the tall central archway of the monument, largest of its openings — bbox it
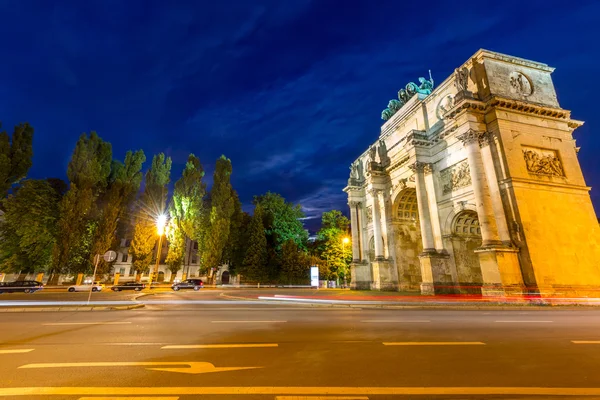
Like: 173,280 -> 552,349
392,188 -> 423,290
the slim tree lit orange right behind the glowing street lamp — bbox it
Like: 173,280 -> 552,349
129,153 -> 172,279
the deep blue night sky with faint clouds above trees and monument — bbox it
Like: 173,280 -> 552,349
0,0 -> 600,229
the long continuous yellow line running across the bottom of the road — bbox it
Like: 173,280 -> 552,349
0,386 -> 600,396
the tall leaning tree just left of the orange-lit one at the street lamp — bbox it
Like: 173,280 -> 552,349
92,150 -> 146,274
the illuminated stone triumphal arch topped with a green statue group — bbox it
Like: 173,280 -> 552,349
344,50 -> 600,296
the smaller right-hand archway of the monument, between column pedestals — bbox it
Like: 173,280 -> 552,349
451,210 -> 483,293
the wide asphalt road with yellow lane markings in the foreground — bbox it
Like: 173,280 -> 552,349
0,304 -> 600,400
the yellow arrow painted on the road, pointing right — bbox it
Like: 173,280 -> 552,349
19,361 -> 262,374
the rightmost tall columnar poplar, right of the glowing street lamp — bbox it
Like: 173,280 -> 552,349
202,156 -> 234,278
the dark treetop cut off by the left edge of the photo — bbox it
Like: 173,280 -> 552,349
0,123 -> 33,199
